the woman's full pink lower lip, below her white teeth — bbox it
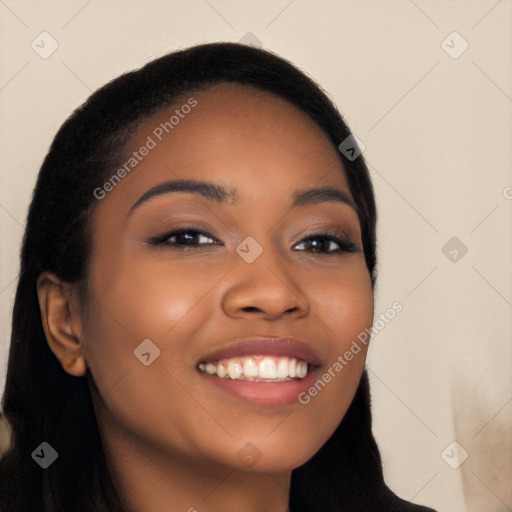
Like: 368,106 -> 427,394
197,368 -> 318,407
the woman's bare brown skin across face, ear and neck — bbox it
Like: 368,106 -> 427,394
38,84 -> 373,512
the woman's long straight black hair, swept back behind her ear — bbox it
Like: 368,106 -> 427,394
0,43 -> 434,512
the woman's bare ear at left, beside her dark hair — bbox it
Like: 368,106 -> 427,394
36,272 -> 87,377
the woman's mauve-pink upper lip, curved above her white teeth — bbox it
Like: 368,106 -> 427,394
199,336 -> 322,366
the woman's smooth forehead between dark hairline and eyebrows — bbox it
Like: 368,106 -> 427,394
98,83 -> 350,211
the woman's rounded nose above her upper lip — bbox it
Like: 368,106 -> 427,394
222,250 -> 310,320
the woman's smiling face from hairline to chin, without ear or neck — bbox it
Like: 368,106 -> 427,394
82,84 -> 373,472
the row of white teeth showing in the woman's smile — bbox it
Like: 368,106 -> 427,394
197,355 -> 311,382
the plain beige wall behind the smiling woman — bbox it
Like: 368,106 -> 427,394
0,0 -> 512,512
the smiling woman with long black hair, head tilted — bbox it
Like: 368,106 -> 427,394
0,43 -> 431,512
